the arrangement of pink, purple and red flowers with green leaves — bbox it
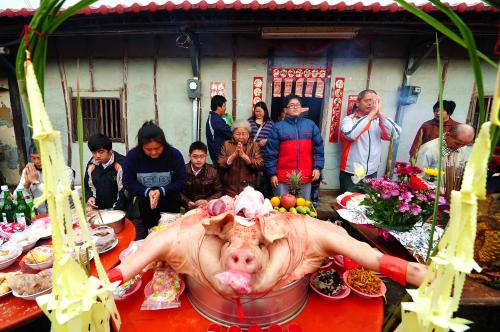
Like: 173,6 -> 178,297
359,162 -> 446,232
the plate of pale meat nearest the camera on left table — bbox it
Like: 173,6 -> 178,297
7,269 -> 52,300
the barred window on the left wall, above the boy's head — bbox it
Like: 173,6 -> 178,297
71,97 -> 125,142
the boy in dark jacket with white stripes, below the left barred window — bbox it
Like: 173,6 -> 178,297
84,134 -> 127,210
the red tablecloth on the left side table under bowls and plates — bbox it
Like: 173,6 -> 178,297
0,220 -> 135,331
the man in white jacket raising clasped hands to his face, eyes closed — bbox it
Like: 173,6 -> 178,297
339,89 -> 401,193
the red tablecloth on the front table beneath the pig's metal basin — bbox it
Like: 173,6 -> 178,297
116,273 -> 384,332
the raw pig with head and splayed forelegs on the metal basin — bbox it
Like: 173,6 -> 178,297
118,192 -> 426,297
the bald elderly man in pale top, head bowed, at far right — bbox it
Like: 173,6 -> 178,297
416,124 -> 474,168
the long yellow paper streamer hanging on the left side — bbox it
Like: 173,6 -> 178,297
25,54 -> 120,332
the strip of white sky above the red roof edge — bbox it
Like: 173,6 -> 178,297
0,0 -> 488,9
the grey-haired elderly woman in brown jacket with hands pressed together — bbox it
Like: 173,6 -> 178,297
218,120 -> 264,196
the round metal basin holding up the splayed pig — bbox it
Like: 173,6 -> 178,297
186,276 -> 309,329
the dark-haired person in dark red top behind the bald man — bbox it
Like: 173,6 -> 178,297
410,100 -> 460,160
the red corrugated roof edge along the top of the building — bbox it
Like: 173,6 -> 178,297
0,0 -> 497,17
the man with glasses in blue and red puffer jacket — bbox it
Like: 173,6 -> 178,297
264,95 -> 325,199
